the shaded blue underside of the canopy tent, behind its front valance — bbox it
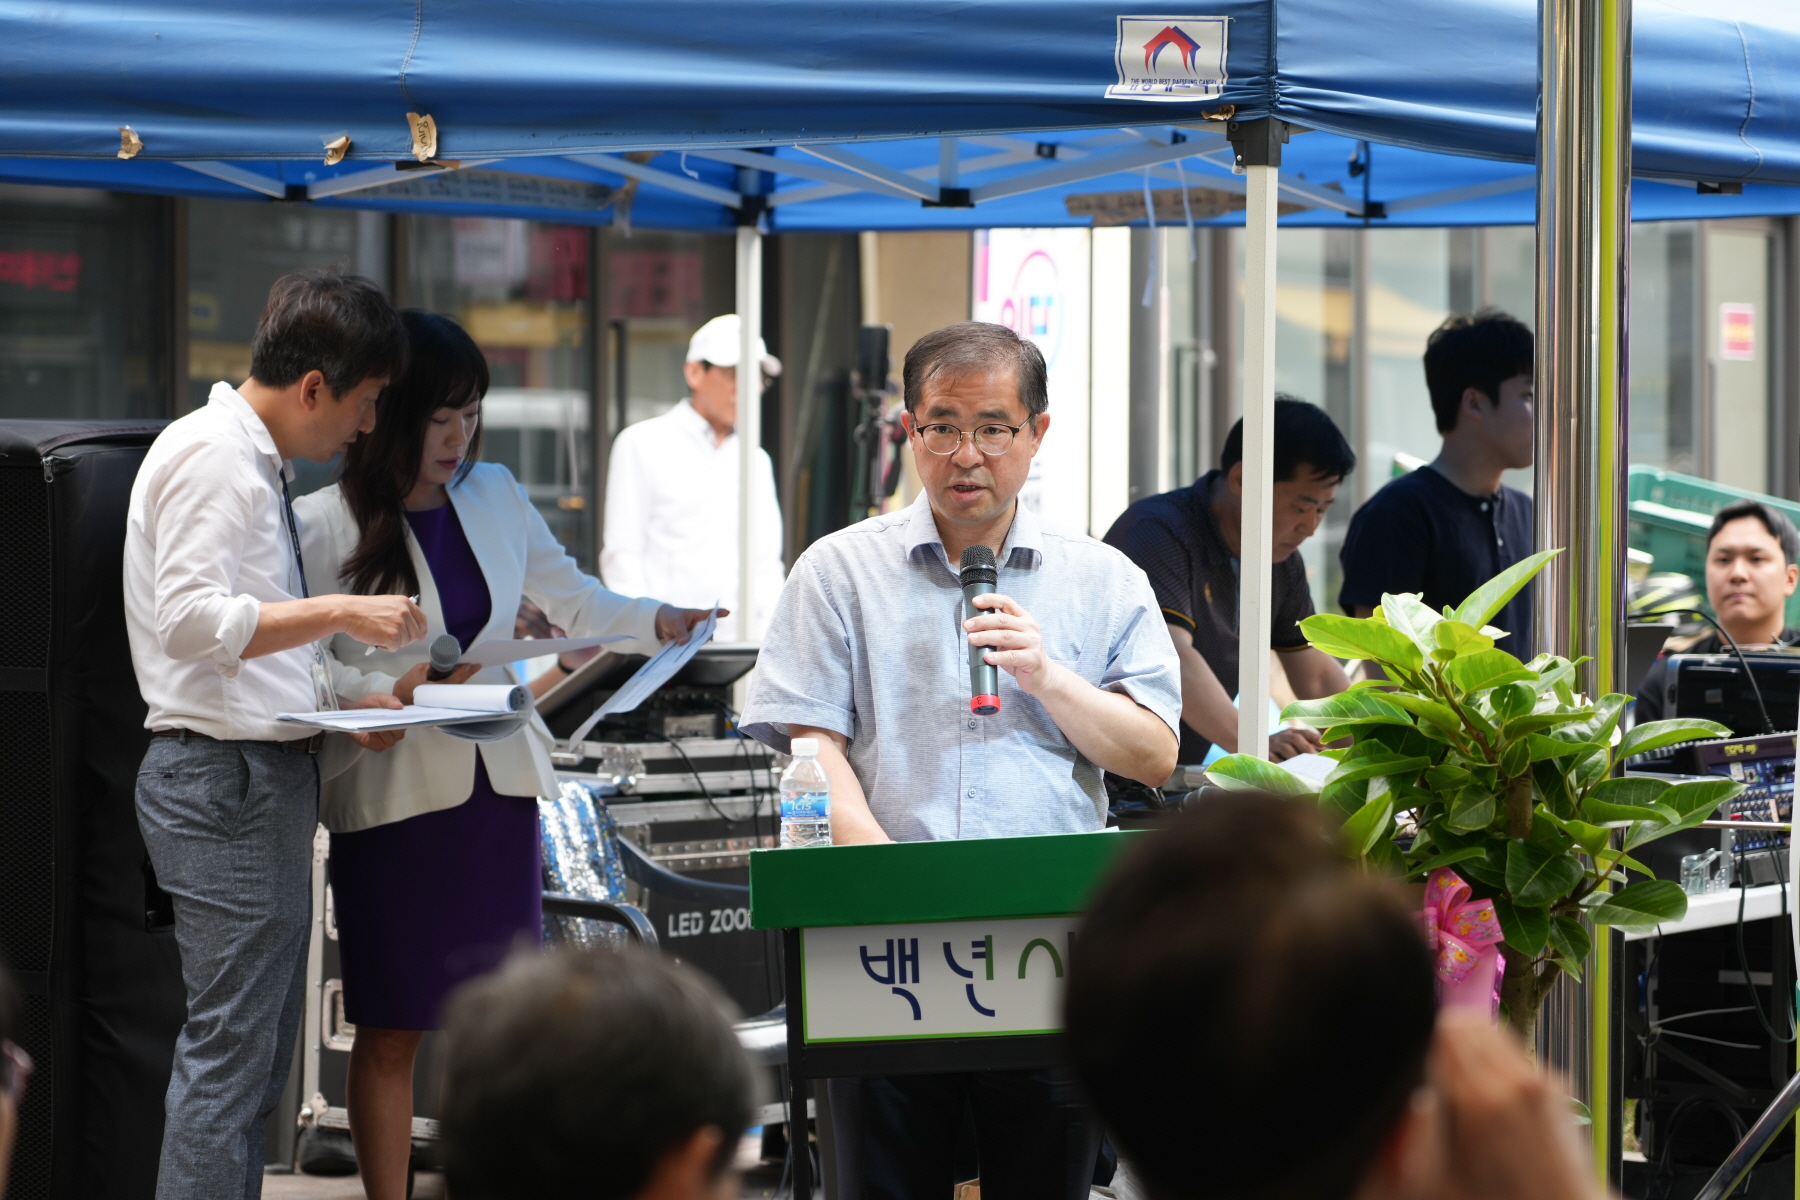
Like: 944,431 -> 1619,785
0,126 -> 1800,234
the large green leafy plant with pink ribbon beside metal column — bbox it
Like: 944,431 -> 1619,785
1208,551 -> 1742,1045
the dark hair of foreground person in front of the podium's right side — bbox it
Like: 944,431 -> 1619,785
1066,792 -> 1436,1200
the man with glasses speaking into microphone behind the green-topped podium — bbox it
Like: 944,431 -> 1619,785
743,322 -> 1181,1200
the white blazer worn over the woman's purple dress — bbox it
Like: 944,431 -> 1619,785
293,462 -> 661,833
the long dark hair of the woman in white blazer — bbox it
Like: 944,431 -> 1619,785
338,308 -> 488,596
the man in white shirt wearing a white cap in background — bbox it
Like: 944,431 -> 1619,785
599,313 -> 785,642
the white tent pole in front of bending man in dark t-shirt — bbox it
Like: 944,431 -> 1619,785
1228,117 -> 1289,759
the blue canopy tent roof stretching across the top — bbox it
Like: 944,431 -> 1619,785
0,0 -> 1800,232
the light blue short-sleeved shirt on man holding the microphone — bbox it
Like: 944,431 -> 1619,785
743,497 -> 1181,842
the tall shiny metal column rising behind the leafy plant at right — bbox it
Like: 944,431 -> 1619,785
1535,0 -> 1631,1178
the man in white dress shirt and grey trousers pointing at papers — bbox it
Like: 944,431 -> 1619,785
124,272 -> 425,1200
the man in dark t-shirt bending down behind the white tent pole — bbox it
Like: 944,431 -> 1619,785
1105,396 -> 1355,765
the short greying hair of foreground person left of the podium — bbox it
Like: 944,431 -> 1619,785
441,950 -> 752,1200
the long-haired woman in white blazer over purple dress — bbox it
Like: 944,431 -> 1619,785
295,311 -> 706,1200
